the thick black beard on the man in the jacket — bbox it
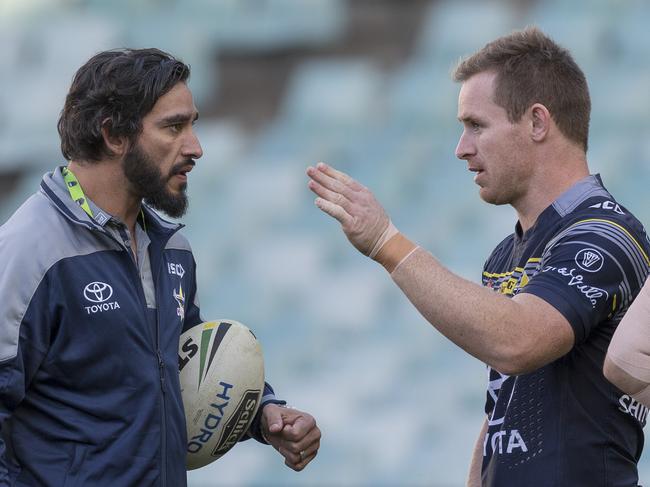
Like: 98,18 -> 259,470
122,144 -> 194,218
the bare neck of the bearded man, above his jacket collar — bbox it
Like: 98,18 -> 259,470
68,160 -> 142,235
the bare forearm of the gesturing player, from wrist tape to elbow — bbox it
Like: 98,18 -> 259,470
382,249 -> 570,375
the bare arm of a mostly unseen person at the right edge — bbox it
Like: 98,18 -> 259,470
604,280 -> 650,407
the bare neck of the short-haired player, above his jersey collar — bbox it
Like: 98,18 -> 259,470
512,148 -> 589,232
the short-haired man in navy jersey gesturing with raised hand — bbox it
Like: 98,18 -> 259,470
307,28 -> 650,487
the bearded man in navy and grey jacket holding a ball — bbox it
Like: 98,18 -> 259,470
0,49 -> 320,487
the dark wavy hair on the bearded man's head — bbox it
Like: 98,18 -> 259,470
57,49 -> 190,162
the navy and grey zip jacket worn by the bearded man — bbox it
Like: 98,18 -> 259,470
0,169 -> 274,487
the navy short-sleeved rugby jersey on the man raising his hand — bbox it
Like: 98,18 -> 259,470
482,176 -> 650,487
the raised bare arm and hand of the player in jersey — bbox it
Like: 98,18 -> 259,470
307,163 -> 574,375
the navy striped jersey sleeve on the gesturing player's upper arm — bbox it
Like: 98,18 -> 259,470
521,219 -> 650,343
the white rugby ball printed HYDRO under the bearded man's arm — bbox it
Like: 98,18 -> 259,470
178,320 -> 264,470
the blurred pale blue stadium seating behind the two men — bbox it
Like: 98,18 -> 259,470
0,0 -> 650,487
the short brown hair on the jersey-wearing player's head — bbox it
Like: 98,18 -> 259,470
453,27 -> 591,152
